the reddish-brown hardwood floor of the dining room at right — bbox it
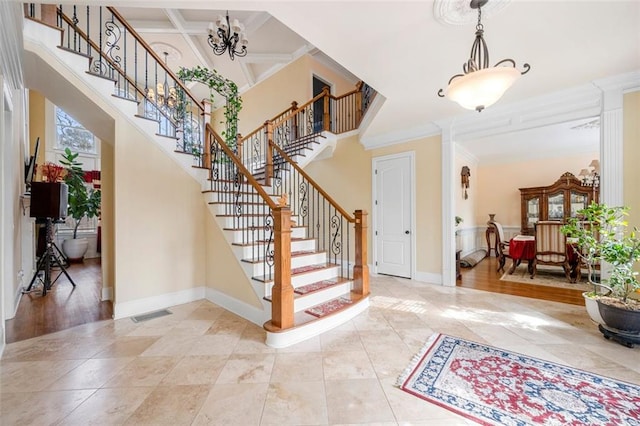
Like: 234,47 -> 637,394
457,253 -> 584,305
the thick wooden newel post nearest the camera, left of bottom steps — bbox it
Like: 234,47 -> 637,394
271,206 -> 294,330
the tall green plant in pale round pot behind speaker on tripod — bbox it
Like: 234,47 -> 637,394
60,148 -> 101,262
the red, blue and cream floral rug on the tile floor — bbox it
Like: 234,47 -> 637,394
398,334 -> 640,426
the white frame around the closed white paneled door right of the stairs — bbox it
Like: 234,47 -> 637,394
369,151 -> 416,279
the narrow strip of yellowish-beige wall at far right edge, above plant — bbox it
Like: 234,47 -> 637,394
622,91 -> 640,227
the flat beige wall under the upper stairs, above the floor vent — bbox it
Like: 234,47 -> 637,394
114,119 -> 206,303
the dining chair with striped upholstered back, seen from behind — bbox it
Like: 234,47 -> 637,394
531,220 -> 571,281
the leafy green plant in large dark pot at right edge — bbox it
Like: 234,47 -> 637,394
562,202 -> 640,339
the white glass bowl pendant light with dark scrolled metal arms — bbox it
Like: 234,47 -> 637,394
438,0 -> 531,112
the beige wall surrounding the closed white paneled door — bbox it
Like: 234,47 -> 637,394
305,136 -> 442,274
